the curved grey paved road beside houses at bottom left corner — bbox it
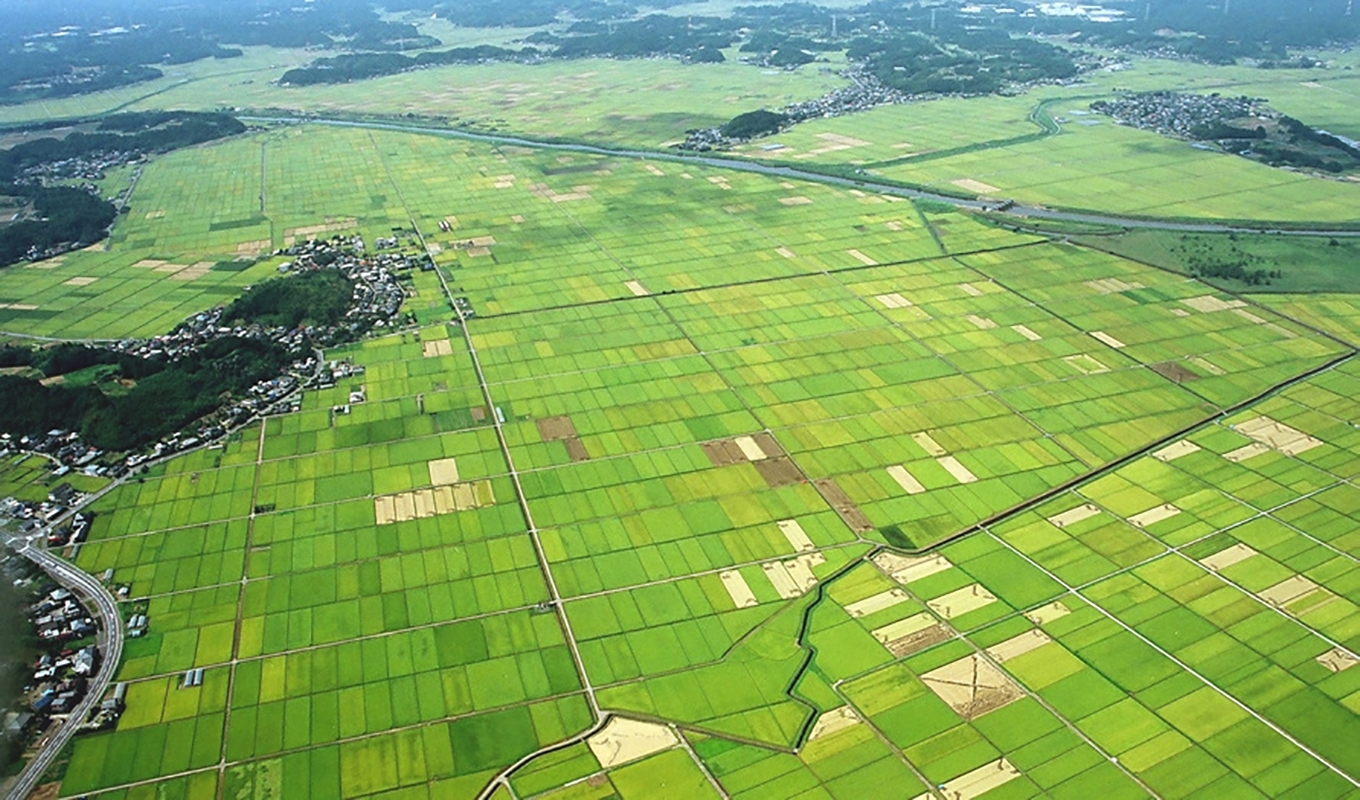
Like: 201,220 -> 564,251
8,529 -> 124,800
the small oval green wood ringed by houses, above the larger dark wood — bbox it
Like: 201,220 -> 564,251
222,269 -> 354,328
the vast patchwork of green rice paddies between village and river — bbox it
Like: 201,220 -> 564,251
10,125 -> 1360,800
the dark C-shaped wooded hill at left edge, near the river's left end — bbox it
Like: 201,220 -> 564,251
0,112 -> 246,267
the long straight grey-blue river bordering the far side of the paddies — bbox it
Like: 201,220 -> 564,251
241,116 -> 1360,238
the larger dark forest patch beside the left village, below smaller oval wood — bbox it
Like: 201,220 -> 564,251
0,337 -> 291,450
